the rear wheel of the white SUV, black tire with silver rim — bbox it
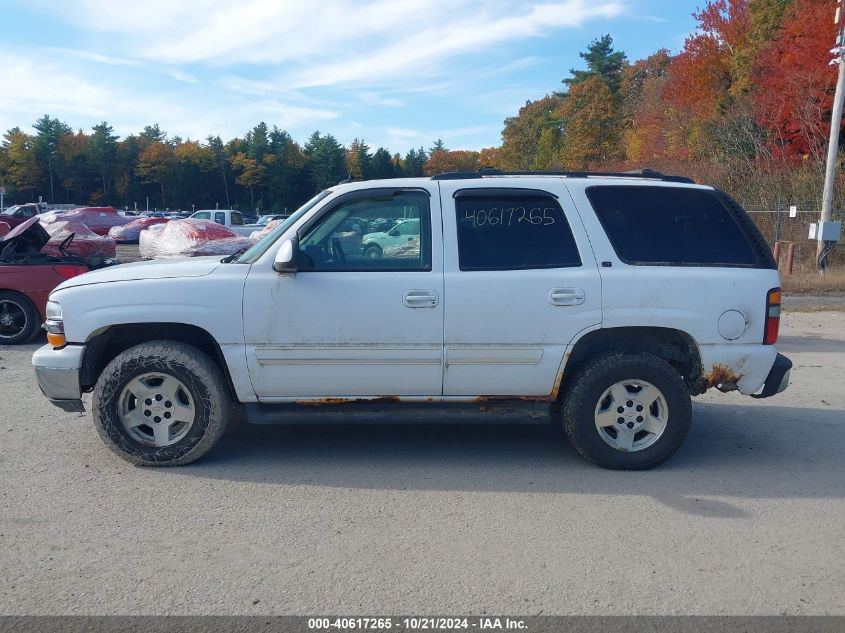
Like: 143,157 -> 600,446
562,353 -> 692,470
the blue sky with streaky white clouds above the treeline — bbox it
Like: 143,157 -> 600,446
0,0 -> 702,154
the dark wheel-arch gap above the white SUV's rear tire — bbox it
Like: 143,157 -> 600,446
560,327 -> 706,395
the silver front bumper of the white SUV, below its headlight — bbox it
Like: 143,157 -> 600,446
32,345 -> 85,413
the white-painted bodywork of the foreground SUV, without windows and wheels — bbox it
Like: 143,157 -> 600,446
33,177 -> 779,402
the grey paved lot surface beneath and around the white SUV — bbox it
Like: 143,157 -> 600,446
0,313 -> 845,614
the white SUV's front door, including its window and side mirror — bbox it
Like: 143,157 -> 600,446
244,187 -> 443,402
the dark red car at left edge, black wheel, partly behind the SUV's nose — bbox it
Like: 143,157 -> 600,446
0,217 -> 88,345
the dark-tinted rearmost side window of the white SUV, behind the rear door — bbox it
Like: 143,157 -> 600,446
586,185 -> 768,267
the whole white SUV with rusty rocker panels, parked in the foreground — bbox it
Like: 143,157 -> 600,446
33,170 -> 791,469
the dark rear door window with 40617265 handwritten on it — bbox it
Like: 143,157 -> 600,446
455,189 -> 581,271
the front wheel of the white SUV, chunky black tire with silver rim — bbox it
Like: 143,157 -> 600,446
92,341 -> 232,466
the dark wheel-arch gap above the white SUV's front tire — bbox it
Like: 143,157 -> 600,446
80,322 -> 238,402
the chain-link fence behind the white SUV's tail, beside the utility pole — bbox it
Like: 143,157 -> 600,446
743,201 -> 845,273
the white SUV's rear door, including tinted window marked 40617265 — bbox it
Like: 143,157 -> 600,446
440,179 -> 601,396
